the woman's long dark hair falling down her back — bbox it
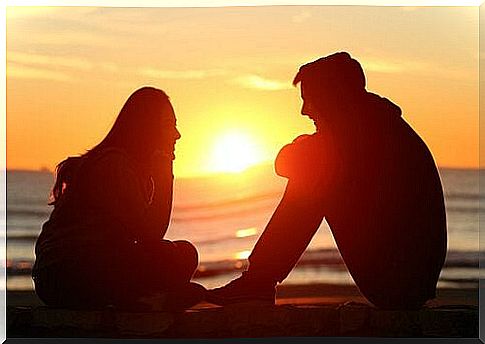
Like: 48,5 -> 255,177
49,87 -> 169,205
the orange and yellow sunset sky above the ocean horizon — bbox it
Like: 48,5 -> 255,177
7,6 -> 478,176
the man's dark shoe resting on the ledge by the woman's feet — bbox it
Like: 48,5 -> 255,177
206,272 -> 276,306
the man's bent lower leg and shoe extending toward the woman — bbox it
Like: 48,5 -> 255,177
208,183 -> 323,304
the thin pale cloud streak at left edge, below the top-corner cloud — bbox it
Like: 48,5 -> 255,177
7,52 -> 93,71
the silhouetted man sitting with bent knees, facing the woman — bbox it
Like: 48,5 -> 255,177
208,52 -> 447,309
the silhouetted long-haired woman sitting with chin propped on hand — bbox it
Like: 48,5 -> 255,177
33,87 -> 204,309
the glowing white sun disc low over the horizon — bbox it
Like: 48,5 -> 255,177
211,132 -> 261,173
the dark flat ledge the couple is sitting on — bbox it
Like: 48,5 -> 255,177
7,303 -> 478,338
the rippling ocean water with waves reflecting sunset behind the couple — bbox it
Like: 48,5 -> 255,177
6,165 -> 485,290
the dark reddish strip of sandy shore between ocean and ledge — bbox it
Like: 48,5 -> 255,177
7,284 -> 478,309
